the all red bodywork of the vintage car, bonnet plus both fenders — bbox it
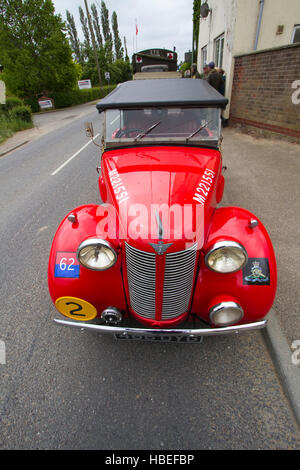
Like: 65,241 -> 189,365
48,146 -> 276,327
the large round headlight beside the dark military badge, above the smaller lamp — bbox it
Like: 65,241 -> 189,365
205,241 -> 248,273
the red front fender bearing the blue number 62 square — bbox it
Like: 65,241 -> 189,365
48,205 -> 127,320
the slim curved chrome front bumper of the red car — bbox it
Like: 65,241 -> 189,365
54,319 -> 267,339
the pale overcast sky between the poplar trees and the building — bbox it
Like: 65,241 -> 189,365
52,0 -> 193,64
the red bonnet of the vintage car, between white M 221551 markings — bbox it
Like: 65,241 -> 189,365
102,147 -> 223,253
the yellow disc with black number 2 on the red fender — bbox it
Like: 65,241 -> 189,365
55,297 -> 97,321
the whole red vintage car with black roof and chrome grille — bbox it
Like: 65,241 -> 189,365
48,79 -> 277,342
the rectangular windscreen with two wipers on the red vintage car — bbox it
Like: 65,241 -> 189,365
106,108 -> 221,144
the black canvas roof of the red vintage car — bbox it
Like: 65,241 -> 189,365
97,78 -> 228,113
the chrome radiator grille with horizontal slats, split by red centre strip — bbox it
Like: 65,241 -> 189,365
126,243 -> 196,320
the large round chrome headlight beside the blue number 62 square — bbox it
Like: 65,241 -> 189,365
77,238 -> 117,271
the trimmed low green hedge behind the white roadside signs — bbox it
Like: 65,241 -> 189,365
24,85 -> 116,112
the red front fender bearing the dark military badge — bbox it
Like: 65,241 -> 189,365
192,207 -> 277,323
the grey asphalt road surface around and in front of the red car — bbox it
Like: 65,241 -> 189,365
0,105 -> 300,450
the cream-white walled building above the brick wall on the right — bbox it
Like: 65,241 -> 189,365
197,0 -> 300,118
